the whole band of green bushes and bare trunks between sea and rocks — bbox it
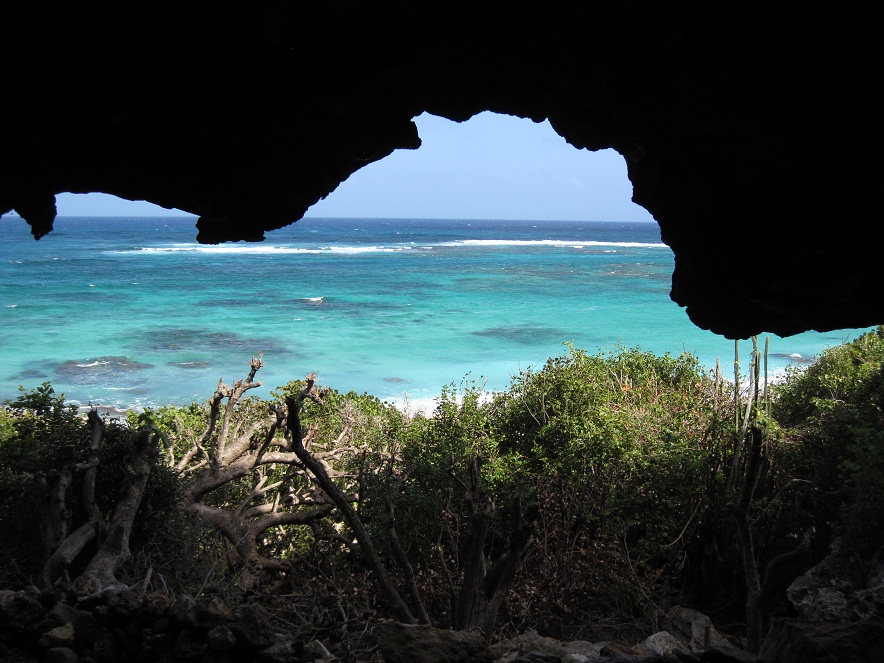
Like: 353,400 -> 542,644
0,328 -> 884,648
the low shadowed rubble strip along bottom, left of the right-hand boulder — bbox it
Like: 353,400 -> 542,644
0,589 -> 753,663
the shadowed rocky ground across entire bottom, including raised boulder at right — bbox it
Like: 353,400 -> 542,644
0,541 -> 884,663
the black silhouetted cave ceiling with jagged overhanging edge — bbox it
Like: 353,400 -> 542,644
0,0 -> 884,337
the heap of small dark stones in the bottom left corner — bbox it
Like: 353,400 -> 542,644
0,590 -> 308,663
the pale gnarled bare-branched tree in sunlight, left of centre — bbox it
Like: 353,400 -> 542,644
143,357 -> 346,589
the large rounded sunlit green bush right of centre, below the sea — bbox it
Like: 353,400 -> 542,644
490,348 -> 718,553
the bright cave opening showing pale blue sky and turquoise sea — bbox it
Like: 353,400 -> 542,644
3,113 -> 872,407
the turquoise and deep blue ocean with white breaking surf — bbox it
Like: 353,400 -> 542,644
0,216 -> 861,416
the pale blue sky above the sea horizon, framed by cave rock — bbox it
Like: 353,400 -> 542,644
50,112 -> 653,221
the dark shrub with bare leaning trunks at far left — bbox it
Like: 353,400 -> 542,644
0,383 -> 165,595
